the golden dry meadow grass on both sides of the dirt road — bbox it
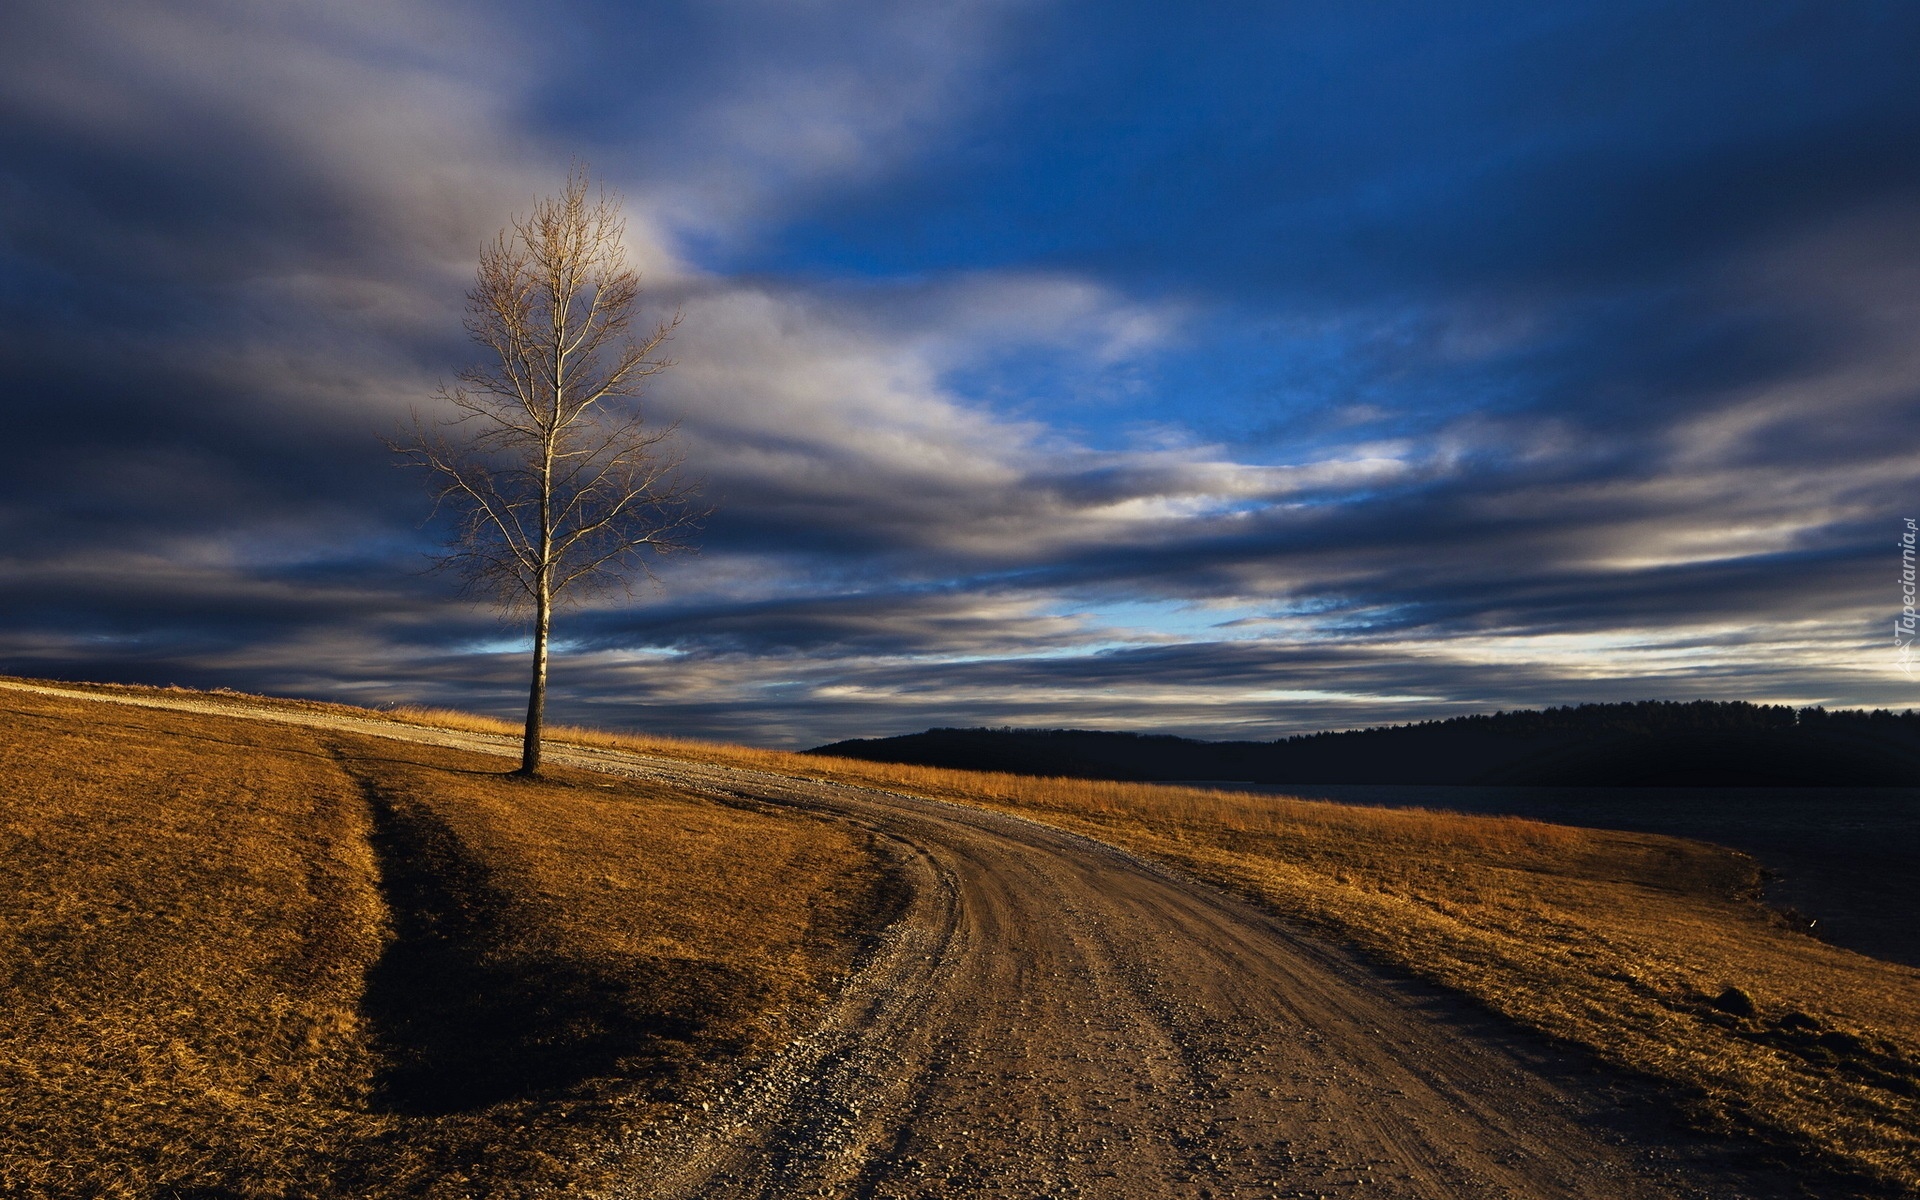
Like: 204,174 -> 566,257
11,679 -> 1920,1196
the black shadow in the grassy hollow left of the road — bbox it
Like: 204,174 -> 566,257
361,764 -> 743,1116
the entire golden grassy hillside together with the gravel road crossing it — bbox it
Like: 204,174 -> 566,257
11,682 -> 1920,1200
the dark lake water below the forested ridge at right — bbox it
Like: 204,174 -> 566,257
1204,781 -> 1920,966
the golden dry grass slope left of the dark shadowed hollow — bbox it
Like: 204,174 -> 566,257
0,695 -> 382,1196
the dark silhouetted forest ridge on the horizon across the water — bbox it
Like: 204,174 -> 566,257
808,701 -> 1920,787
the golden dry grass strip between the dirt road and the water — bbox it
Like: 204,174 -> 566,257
370,710 -> 1920,1194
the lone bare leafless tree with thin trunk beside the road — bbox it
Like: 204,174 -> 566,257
394,171 -> 703,776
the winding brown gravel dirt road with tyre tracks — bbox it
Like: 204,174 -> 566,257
0,693 -> 1788,1200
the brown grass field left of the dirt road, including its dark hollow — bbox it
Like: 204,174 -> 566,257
0,691 -> 876,1200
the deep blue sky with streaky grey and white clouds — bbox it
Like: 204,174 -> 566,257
0,0 -> 1920,747
